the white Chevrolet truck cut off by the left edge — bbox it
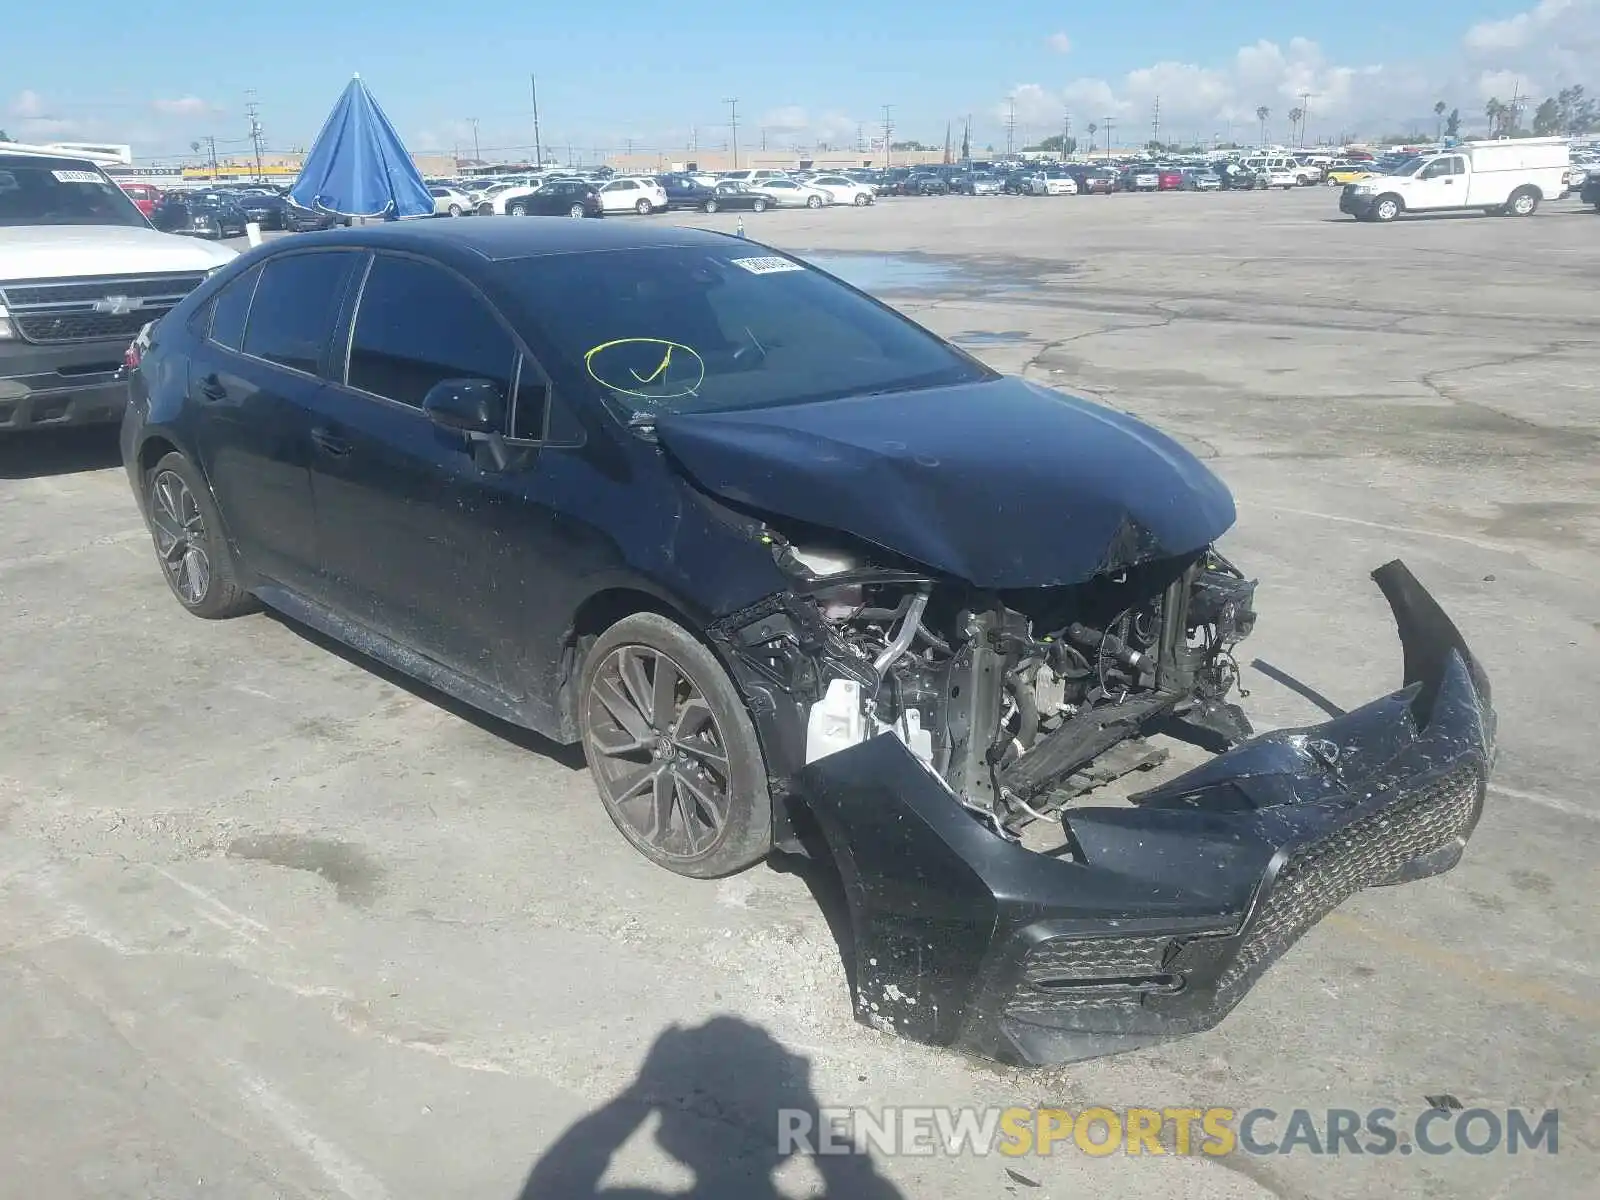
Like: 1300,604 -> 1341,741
0,142 -> 235,437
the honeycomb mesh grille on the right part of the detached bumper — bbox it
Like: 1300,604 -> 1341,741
1218,765 -> 1483,1005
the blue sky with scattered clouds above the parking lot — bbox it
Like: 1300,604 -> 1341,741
0,0 -> 1600,157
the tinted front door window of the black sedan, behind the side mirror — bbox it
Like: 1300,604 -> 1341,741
349,258 -> 518,412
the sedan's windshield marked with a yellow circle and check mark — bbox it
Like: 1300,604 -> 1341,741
504,246 -> 992,419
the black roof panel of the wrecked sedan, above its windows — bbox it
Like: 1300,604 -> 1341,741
270,216 -> 742,262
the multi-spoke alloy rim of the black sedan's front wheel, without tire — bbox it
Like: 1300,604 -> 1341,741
584,645 -> 730,859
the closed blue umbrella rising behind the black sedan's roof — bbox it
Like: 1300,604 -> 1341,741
290,75 -> 434,218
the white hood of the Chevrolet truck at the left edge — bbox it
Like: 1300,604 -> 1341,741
0,226 -> 235,280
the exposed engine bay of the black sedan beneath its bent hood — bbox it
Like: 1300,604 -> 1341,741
713,531 -> 1256,840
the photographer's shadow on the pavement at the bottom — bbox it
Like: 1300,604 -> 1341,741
520,1016 -> 904,1200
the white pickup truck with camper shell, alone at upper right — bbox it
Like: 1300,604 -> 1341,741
1339,138 -> 1571,221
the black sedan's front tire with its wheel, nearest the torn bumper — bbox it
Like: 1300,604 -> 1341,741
578,613 -> 773,878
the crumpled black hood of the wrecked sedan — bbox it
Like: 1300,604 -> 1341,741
656,378 -> 1235,589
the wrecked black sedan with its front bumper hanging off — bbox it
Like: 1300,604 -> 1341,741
122,221 -> 1494,1064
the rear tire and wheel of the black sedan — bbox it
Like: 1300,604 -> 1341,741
144,451 -> 256,621
